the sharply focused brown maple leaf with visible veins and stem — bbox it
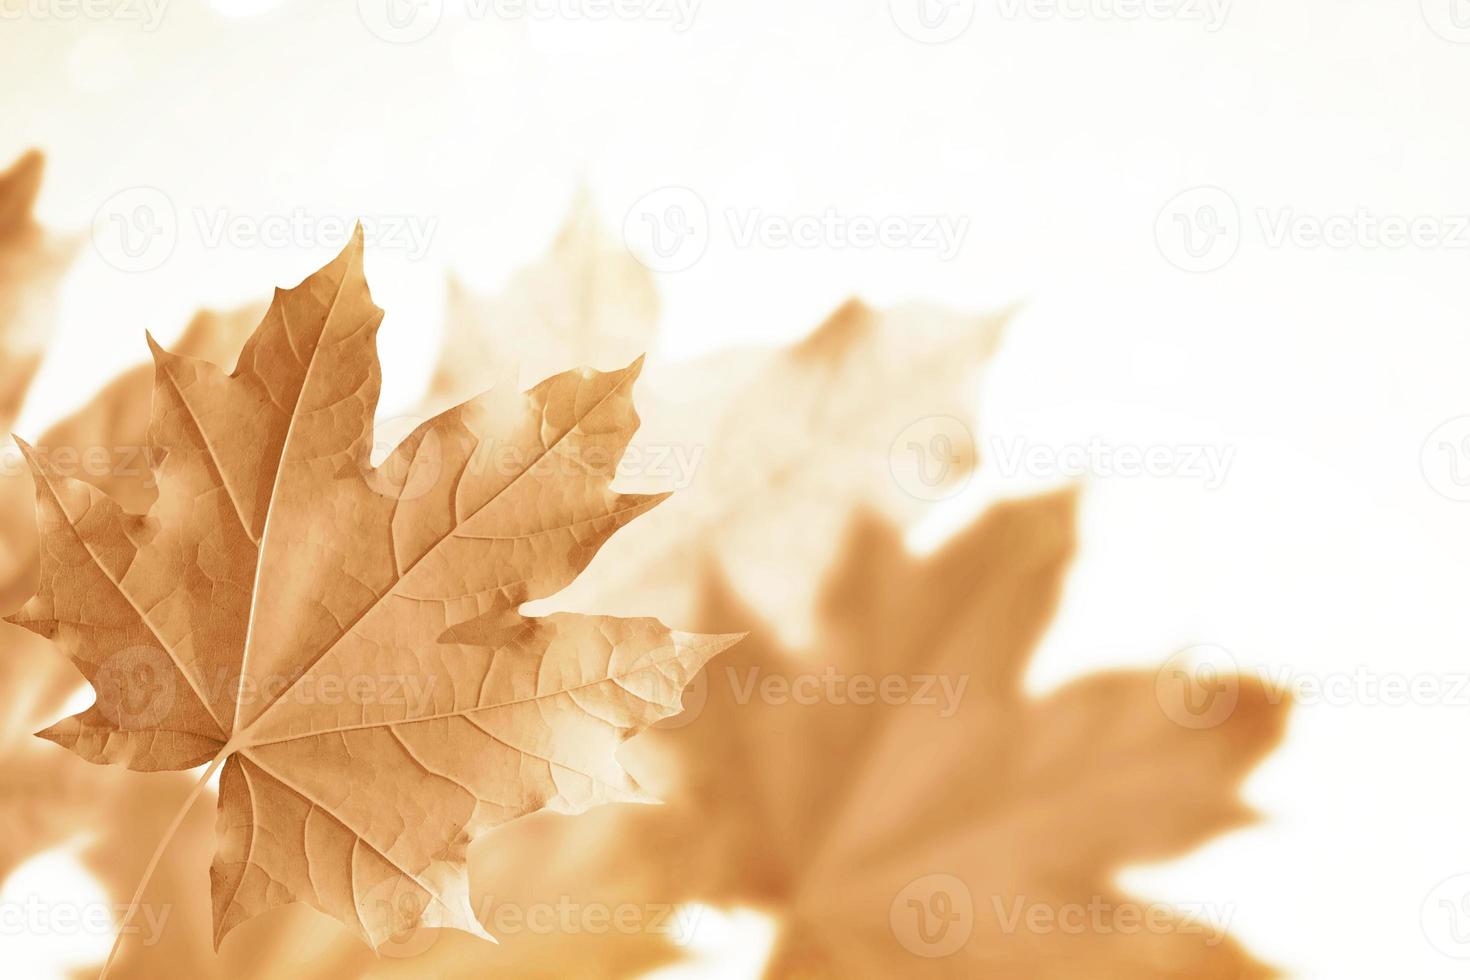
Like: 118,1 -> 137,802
12,234 -> 735,946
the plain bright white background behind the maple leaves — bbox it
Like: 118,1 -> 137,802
0,0 -> 1470,980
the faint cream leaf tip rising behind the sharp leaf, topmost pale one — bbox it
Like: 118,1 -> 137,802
431,192 -> 659,404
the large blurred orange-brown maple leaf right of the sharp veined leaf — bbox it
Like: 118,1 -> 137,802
467,494 -> 1285,980
